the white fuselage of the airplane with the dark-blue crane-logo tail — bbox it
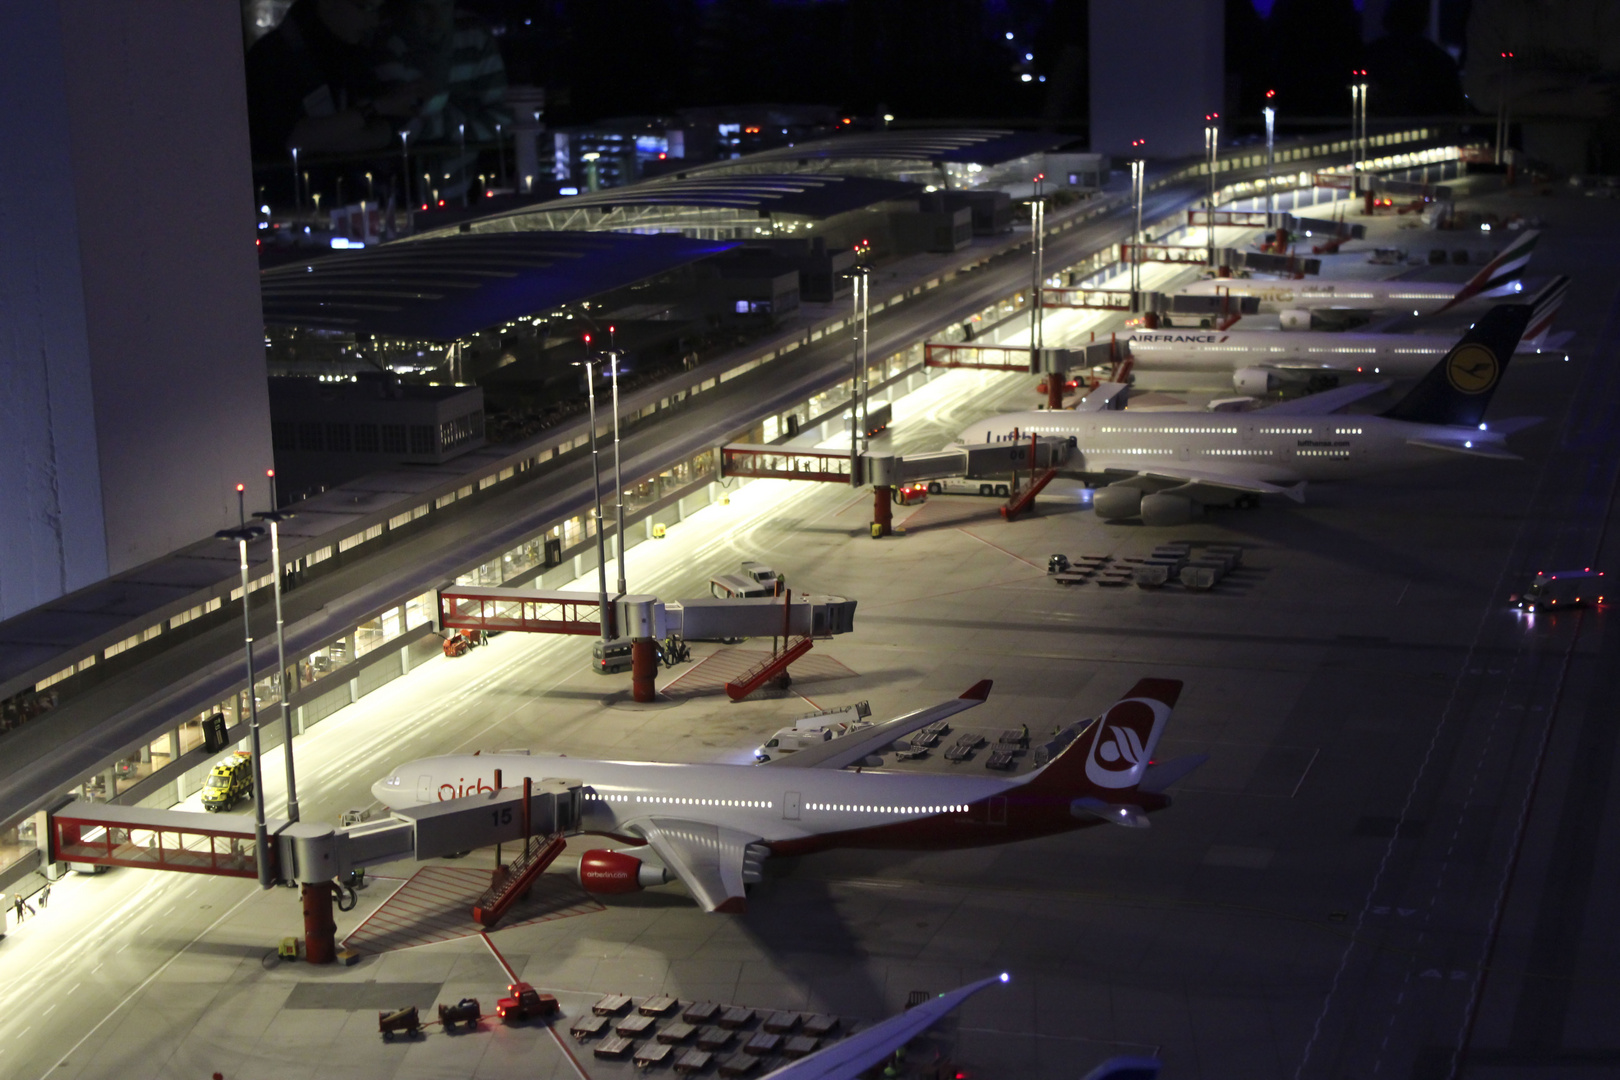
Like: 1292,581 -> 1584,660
957,410 -> 1503,484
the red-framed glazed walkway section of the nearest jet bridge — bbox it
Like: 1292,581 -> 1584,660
49,801 -> 275,879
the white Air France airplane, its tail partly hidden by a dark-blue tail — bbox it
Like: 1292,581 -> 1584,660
1121,277 -> 1570,393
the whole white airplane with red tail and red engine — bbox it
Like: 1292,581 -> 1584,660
371,678 -> 1207,913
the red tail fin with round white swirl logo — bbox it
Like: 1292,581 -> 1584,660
1022,678 -> 1181,826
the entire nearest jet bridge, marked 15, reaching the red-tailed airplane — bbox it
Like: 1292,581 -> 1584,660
45,772 -> 585,963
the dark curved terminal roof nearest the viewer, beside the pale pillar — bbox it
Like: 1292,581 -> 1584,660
259,232 -> 735,342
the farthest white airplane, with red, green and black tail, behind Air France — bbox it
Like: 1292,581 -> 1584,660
1178,230 -> 1541,318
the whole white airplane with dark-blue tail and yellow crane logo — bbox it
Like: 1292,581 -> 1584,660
956,304 -> 1539,525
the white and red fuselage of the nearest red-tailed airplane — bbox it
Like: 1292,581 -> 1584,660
371,755 -> 1166,855
